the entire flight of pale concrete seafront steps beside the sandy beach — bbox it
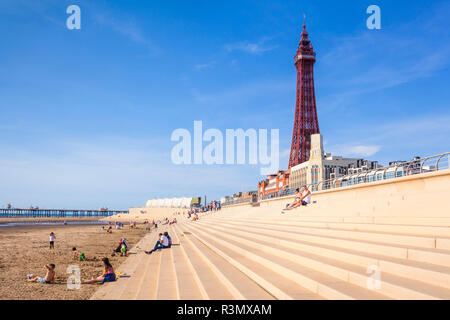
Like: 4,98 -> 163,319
91,170 -> 450,300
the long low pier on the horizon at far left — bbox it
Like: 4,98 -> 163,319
0,209 -> 128,218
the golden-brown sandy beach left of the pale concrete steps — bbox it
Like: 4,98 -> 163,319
0,225 -> 146,300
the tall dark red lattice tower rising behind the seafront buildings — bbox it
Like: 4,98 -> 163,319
289,24 -> 320,168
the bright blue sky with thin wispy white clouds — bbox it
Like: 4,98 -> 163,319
0,0 -> 450,209
